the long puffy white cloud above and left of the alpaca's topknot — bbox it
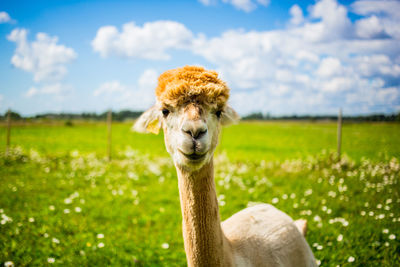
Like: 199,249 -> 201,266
92,21 -> 193,60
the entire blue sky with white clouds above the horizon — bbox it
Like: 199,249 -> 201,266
0,0 -> 400,115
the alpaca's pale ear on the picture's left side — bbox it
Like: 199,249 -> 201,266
132,106 -> 161,134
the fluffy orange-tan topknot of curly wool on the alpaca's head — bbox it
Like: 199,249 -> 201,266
156,66 -> 229,107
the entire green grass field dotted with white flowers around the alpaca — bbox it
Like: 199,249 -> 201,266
0,122 -> 400,266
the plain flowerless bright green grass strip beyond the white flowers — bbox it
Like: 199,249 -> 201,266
0,122 -> 400,161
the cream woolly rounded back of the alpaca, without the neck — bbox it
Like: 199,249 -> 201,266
221,204 -> 316,267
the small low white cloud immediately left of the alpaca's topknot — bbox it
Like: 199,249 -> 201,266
93,69 -> 158,110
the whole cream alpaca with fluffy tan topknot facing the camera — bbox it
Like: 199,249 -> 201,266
133,66 -> 315,266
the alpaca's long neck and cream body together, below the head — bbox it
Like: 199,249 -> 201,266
177,159 -> 315,267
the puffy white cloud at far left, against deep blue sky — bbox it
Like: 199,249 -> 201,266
7,29 -> 77,82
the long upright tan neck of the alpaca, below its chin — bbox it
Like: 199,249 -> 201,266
177,159 -> 232,267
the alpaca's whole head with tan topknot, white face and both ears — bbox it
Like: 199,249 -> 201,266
134,66 -> 239,171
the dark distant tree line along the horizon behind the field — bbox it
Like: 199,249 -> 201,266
0,110 -> 400,122
